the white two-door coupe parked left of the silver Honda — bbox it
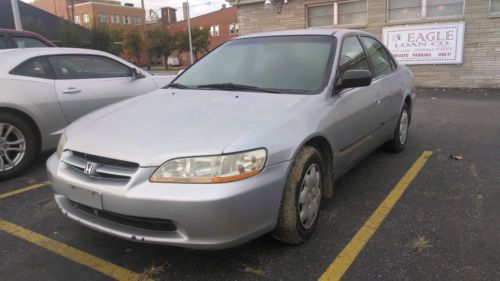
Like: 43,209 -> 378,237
0,48 -> 175,179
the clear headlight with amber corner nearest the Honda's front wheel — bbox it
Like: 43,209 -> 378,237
150,149 -> 267,183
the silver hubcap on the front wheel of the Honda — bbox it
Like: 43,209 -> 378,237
298,164 -> 321,229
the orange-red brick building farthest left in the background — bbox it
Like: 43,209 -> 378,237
32,0 -> 145,30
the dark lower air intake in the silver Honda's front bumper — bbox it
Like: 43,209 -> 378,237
71,201 -> 177,231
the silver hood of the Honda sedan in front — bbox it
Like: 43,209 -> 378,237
65,89 -> 307,167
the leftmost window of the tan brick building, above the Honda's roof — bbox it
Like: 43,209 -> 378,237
307,0 -> 368,27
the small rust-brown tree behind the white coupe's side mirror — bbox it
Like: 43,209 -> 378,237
146,27 -> 176,69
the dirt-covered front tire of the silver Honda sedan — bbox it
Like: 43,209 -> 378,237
272,146 -> 326,244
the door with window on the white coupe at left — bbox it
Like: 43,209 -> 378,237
49,54 -> 156,122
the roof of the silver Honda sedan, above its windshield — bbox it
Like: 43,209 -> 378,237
235,28 -> 371,40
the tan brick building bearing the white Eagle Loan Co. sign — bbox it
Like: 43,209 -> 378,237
229,0 -> 500,88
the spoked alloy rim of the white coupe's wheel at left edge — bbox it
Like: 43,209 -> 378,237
0,122 -> 26,172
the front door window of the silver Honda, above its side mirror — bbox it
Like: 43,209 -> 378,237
339,36 -> 370,74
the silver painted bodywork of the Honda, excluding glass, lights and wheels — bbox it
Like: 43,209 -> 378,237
47,29 -> 415,248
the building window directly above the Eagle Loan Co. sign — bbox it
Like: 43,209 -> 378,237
387,0 -> 464,21
